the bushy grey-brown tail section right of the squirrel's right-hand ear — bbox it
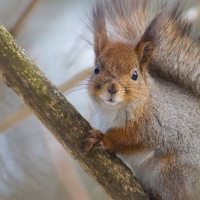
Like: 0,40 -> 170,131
144,2 -> 200,95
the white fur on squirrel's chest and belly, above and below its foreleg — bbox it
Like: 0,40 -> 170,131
90,102 -> 157,188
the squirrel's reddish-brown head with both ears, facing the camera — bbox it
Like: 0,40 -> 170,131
88,0 -> 154,107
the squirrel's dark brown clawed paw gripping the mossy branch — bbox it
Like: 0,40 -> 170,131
84,130 -> 105,151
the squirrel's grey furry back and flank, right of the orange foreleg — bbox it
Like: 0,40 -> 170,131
140,78 -> 200,200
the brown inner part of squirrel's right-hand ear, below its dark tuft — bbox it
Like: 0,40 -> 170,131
136,41 -> 155,75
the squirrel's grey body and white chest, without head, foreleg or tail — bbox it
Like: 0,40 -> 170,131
90,74 -> 200,200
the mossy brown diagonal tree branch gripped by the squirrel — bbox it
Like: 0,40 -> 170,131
0,26 -> 148,200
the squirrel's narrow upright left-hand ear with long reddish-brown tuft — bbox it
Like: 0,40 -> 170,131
92,1 -> 108,57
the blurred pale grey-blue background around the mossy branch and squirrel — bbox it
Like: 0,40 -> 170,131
0,0 -> 200,200
